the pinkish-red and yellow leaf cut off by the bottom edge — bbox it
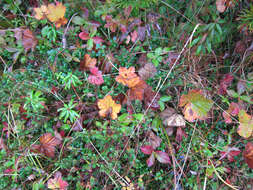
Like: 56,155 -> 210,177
47,172 -> 69,190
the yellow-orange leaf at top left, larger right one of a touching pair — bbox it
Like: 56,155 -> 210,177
46,1 -> 68,28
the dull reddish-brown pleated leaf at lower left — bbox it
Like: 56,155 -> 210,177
32,133 -> 61,158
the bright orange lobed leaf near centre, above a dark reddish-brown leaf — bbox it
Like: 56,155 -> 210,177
116,67 -> 140,88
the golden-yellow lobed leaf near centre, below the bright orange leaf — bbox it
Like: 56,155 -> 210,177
98,95 -> 121,119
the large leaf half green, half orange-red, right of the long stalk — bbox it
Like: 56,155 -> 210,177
179,90 -> 213,122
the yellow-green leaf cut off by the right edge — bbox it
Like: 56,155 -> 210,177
237,110 -> 253,138
